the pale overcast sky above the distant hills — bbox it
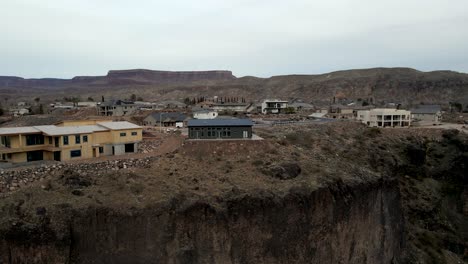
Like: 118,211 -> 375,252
0,0 -> 468,78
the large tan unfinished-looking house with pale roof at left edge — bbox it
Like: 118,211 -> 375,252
0,121 -> 142,163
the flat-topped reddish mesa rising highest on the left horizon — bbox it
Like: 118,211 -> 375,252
107,69 -> 236,83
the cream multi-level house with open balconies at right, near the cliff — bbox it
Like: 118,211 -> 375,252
356,108 -> 411,127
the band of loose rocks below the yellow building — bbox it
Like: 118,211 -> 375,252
0,157 -> 157,193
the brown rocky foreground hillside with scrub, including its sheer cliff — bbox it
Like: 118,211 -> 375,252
0,123 -> 468,264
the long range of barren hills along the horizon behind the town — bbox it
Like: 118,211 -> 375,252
0,68 -> 468,104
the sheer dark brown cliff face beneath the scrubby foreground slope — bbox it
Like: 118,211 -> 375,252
0,178 -> 404,263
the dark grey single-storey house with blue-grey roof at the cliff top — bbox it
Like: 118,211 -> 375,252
187,119 -> 253,139
